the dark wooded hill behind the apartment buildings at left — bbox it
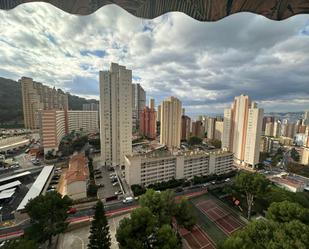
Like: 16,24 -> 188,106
0,77 -> 99,128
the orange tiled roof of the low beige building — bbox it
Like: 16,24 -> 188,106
65,154 -> 89,184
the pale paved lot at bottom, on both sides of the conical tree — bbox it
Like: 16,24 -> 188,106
57,214 -> 130,249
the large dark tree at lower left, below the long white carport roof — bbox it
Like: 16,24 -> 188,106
26,192 -> 72,244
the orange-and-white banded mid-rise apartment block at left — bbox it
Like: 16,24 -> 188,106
39,110 -> 67,154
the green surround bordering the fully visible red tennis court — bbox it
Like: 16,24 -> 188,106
190,193 -> 245,245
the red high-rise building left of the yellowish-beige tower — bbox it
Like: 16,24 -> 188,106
139,106 -> 157,139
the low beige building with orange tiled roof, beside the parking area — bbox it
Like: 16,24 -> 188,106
63,154 -> 89,200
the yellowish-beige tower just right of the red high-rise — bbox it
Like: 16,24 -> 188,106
160,97 -> 182,147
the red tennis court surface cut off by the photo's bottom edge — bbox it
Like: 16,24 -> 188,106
180,226 -> 216,249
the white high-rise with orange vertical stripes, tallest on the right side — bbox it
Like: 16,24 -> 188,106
222,95 -> 264,167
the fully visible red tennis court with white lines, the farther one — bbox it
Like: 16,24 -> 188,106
196,200 -> 244,235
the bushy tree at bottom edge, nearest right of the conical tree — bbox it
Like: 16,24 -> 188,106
116,207 -> 156,249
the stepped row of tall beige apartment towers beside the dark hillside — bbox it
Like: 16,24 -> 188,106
19,77 -> 68,129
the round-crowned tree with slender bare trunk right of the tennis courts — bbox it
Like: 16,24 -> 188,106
235,171 -> 269,220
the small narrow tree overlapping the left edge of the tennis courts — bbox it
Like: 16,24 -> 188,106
175,198 -> 196,231
